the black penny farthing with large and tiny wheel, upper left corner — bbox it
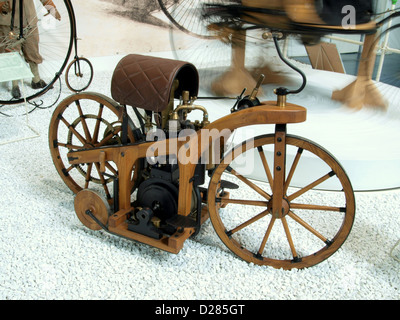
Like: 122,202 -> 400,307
0,0 -> 93,105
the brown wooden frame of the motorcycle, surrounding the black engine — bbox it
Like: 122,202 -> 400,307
68,101 -> 306,253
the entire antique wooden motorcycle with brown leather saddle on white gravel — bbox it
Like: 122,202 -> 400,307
49,36 -> 355,269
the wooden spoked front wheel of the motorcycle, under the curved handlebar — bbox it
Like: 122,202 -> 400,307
208,134 -> 355,269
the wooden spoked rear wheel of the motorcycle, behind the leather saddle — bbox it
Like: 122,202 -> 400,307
49,92 -> 138,204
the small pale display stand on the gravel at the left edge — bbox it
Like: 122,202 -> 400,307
0,52 -> 40,145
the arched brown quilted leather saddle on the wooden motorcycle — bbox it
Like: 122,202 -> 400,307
111,54 -> 199,112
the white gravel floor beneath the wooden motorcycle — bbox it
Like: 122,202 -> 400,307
0,59 -> 400,300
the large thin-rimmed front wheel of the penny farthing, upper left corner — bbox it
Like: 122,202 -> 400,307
0,0 -> 75,105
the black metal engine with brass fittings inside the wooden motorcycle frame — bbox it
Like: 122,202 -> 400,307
128,85 -> 210,239
